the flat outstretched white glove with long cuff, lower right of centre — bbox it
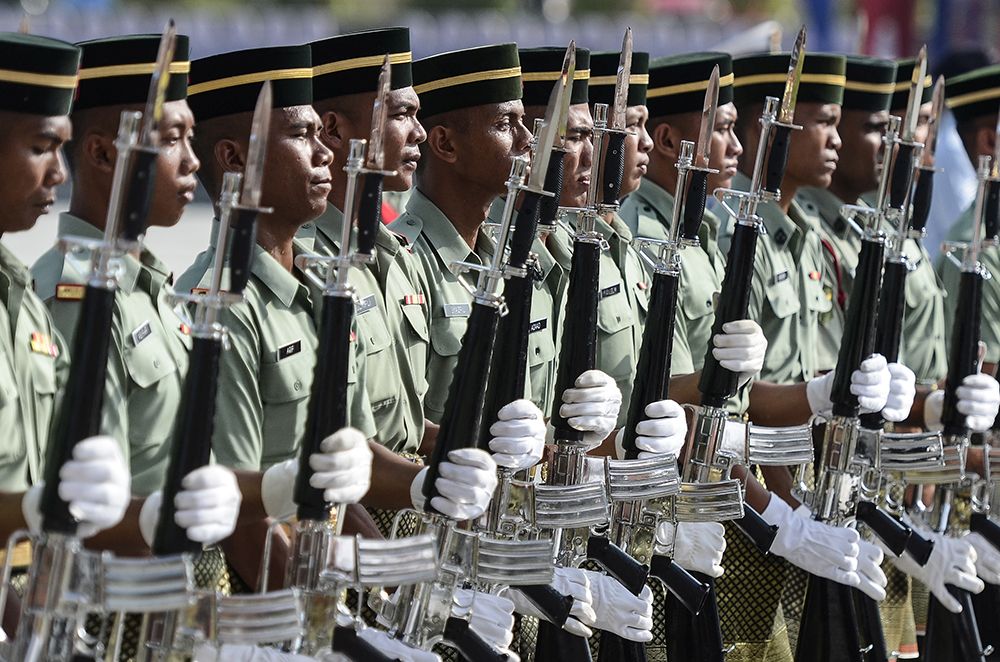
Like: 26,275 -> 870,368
760,494 -> 861,586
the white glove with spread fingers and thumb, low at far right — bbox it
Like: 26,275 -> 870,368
891,522 -> 986,614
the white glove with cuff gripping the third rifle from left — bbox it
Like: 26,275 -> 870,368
260,428 -> 372,519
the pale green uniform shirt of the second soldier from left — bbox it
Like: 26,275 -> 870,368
31,213 -> 191,496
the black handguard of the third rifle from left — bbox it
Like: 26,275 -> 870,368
294,294 -> 354,522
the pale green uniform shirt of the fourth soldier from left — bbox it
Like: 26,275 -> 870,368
312,205 -> 428,453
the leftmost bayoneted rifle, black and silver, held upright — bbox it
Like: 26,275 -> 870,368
0,26 -> 176,662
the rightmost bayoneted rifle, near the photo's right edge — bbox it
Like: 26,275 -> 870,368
923,150 -> 1000,662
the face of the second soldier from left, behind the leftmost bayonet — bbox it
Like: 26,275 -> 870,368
149,100 -> 201,227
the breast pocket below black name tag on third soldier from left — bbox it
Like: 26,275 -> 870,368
260,351 -> 315,466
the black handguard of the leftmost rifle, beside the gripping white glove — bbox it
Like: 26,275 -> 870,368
40,285 -> 115,535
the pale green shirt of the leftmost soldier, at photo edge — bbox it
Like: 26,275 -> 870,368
0,244 -> 69,492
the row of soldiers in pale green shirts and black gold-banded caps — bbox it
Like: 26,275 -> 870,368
0,20 -> 1000,660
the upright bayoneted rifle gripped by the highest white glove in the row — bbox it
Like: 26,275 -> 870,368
669,27 -> 811,662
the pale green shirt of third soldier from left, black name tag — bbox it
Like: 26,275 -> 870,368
178,228 -> 375,471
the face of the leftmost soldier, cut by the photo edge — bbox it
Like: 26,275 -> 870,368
0,113 -> 73,233
